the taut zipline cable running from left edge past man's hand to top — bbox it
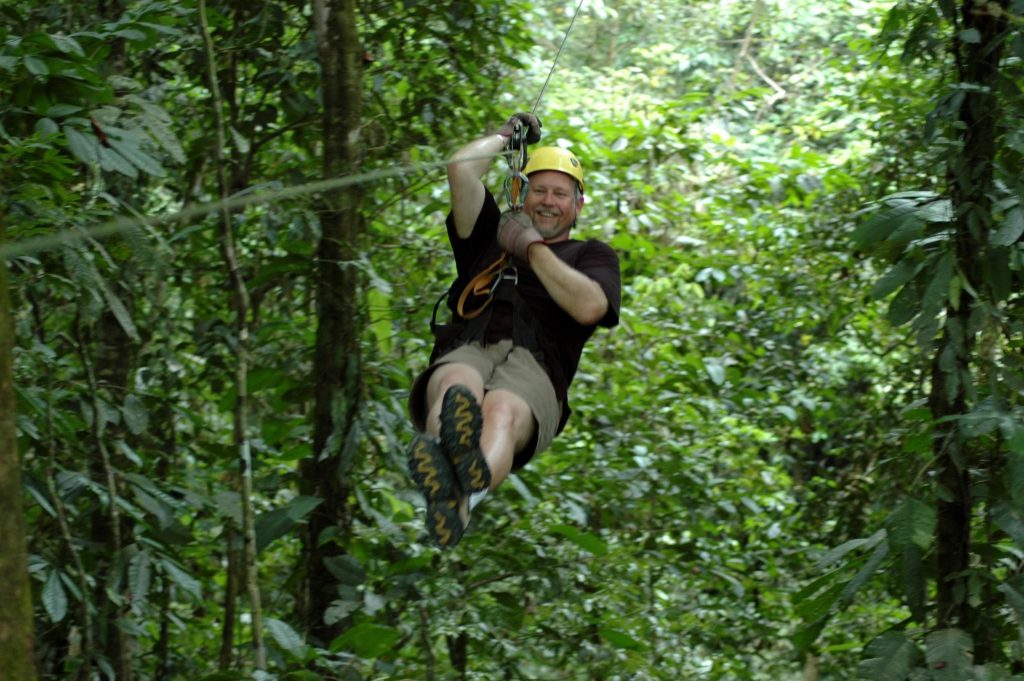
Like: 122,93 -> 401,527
0,0 -> 585,259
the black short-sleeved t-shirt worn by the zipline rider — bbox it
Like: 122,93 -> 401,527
444,191 -> 622,430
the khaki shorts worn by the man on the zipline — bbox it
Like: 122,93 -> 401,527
409,340 -> 562,469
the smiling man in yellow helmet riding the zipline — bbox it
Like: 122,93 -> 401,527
409,114 -> 621,547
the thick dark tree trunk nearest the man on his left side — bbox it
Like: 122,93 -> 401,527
301,0 -> 362,644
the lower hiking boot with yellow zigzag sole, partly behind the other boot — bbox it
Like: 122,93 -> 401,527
409,433 -> 466,548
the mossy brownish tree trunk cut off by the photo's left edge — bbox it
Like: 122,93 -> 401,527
0,220 -> 36,681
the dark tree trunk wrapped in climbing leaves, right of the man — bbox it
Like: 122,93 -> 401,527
929,0 -> 1006,643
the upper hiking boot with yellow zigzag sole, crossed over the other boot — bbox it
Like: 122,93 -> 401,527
440,385 -> 490,496
